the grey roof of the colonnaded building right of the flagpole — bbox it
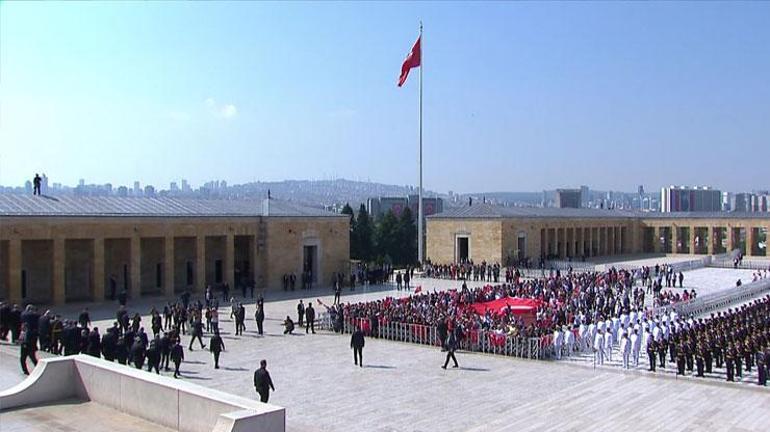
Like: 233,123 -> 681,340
428,203 -> 770,220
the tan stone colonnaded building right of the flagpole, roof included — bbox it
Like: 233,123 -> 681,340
426,203 -> 770,264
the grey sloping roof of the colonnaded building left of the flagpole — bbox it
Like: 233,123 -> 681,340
0,194 -> 347,217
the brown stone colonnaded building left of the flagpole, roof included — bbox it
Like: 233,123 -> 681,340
0,195 -> 350,304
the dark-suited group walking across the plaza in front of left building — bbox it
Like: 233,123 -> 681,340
0,289 -> 276,378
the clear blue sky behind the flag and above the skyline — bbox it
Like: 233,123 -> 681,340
0,2 -> 770,192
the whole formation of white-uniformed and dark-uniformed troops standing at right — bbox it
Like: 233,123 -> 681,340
552,296 -> 770,386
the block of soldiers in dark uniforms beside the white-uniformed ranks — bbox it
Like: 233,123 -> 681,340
646,296 -> 770,386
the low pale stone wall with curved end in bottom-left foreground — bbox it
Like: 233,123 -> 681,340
0,355 -> 286,432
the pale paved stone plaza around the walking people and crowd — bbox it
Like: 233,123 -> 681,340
0,262 -> 770,432
